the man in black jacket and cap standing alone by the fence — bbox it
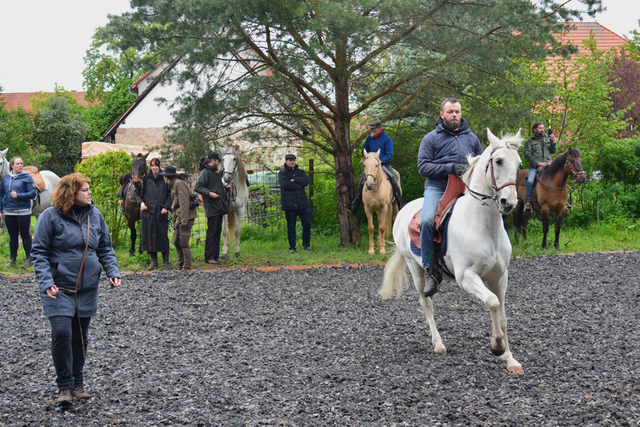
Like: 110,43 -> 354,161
278,154 -> 311,253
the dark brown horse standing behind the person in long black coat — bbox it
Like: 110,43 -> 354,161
119,153 -> 149,256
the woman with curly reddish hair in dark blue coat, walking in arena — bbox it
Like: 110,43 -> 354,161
31,172 -> 121,406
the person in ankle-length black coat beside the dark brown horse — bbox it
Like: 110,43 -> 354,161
139,158 -> 172,271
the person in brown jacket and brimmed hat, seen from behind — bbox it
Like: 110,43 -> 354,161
162,166 -> 198,270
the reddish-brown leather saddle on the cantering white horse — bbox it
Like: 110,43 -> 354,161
409,175 -> 465,255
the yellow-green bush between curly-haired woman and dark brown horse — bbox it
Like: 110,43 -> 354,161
76,150 -> 131,245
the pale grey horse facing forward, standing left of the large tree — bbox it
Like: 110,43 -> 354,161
221,145 -> 249,259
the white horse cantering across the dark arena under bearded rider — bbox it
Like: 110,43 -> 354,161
379,129 -> 524,374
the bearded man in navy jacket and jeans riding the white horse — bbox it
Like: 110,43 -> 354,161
418,98 -> 483,296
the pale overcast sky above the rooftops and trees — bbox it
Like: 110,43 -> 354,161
0,0 -> 640,93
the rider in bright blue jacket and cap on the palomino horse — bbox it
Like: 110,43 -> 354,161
347,119 -> 402,212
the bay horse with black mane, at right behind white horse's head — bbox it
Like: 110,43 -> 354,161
513,147 -> 586,251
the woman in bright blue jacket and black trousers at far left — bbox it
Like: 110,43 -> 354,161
0,157 -> 36,268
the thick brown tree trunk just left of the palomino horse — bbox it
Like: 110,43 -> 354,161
334,43 -> 360,246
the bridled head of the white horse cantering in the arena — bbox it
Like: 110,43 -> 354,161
465,129 -> 523,214
